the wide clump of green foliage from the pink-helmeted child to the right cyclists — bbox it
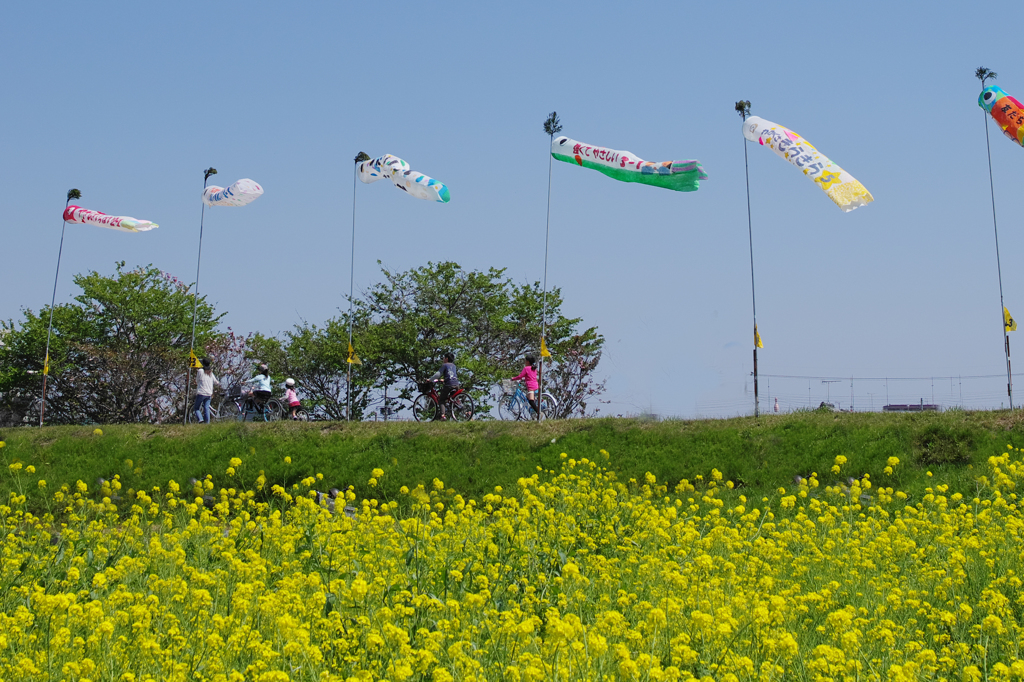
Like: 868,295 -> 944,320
253,262 -> 604,420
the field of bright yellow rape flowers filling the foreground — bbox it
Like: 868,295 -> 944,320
0,449 -> 1024,682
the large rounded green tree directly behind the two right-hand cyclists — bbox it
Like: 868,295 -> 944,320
355,262 -> 604,417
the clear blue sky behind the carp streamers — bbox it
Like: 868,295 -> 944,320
0,0 -> 1024,417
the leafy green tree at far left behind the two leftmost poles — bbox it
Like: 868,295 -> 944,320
0,261 -> 220,423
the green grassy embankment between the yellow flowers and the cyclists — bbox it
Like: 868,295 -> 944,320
0,405 -> 1024,503
